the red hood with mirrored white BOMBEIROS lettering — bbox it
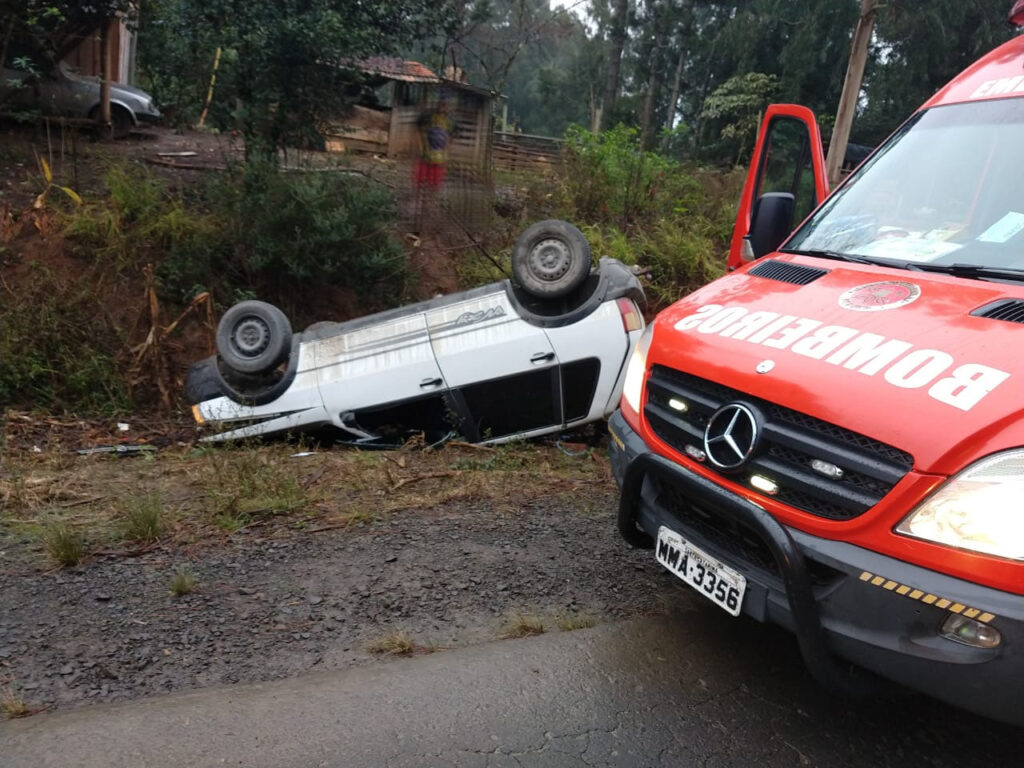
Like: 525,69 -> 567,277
648,259 -> 1024,474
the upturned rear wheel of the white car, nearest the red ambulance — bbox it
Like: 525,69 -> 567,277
512,219 -> 591,299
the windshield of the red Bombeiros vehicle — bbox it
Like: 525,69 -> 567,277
781,98 -> 1024,271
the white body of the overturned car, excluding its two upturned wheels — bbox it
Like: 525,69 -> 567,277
187,259 -> 643,442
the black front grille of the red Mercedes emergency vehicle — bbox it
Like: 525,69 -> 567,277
644,366 -> 913,520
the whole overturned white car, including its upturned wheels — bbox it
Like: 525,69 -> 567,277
186,221 -> 644,442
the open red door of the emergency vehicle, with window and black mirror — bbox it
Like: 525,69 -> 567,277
729,104 -> 828,271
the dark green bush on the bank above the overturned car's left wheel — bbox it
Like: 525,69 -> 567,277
160,163 -> 408,301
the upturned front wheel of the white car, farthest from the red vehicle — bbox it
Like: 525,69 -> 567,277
217,301 -> 292,374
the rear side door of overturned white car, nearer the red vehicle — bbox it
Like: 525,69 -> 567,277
427,290 -> 562,440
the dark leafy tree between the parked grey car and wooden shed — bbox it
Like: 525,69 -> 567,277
140,0 -> 454,156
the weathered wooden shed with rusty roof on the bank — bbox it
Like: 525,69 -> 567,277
322,56 -> 494,168
